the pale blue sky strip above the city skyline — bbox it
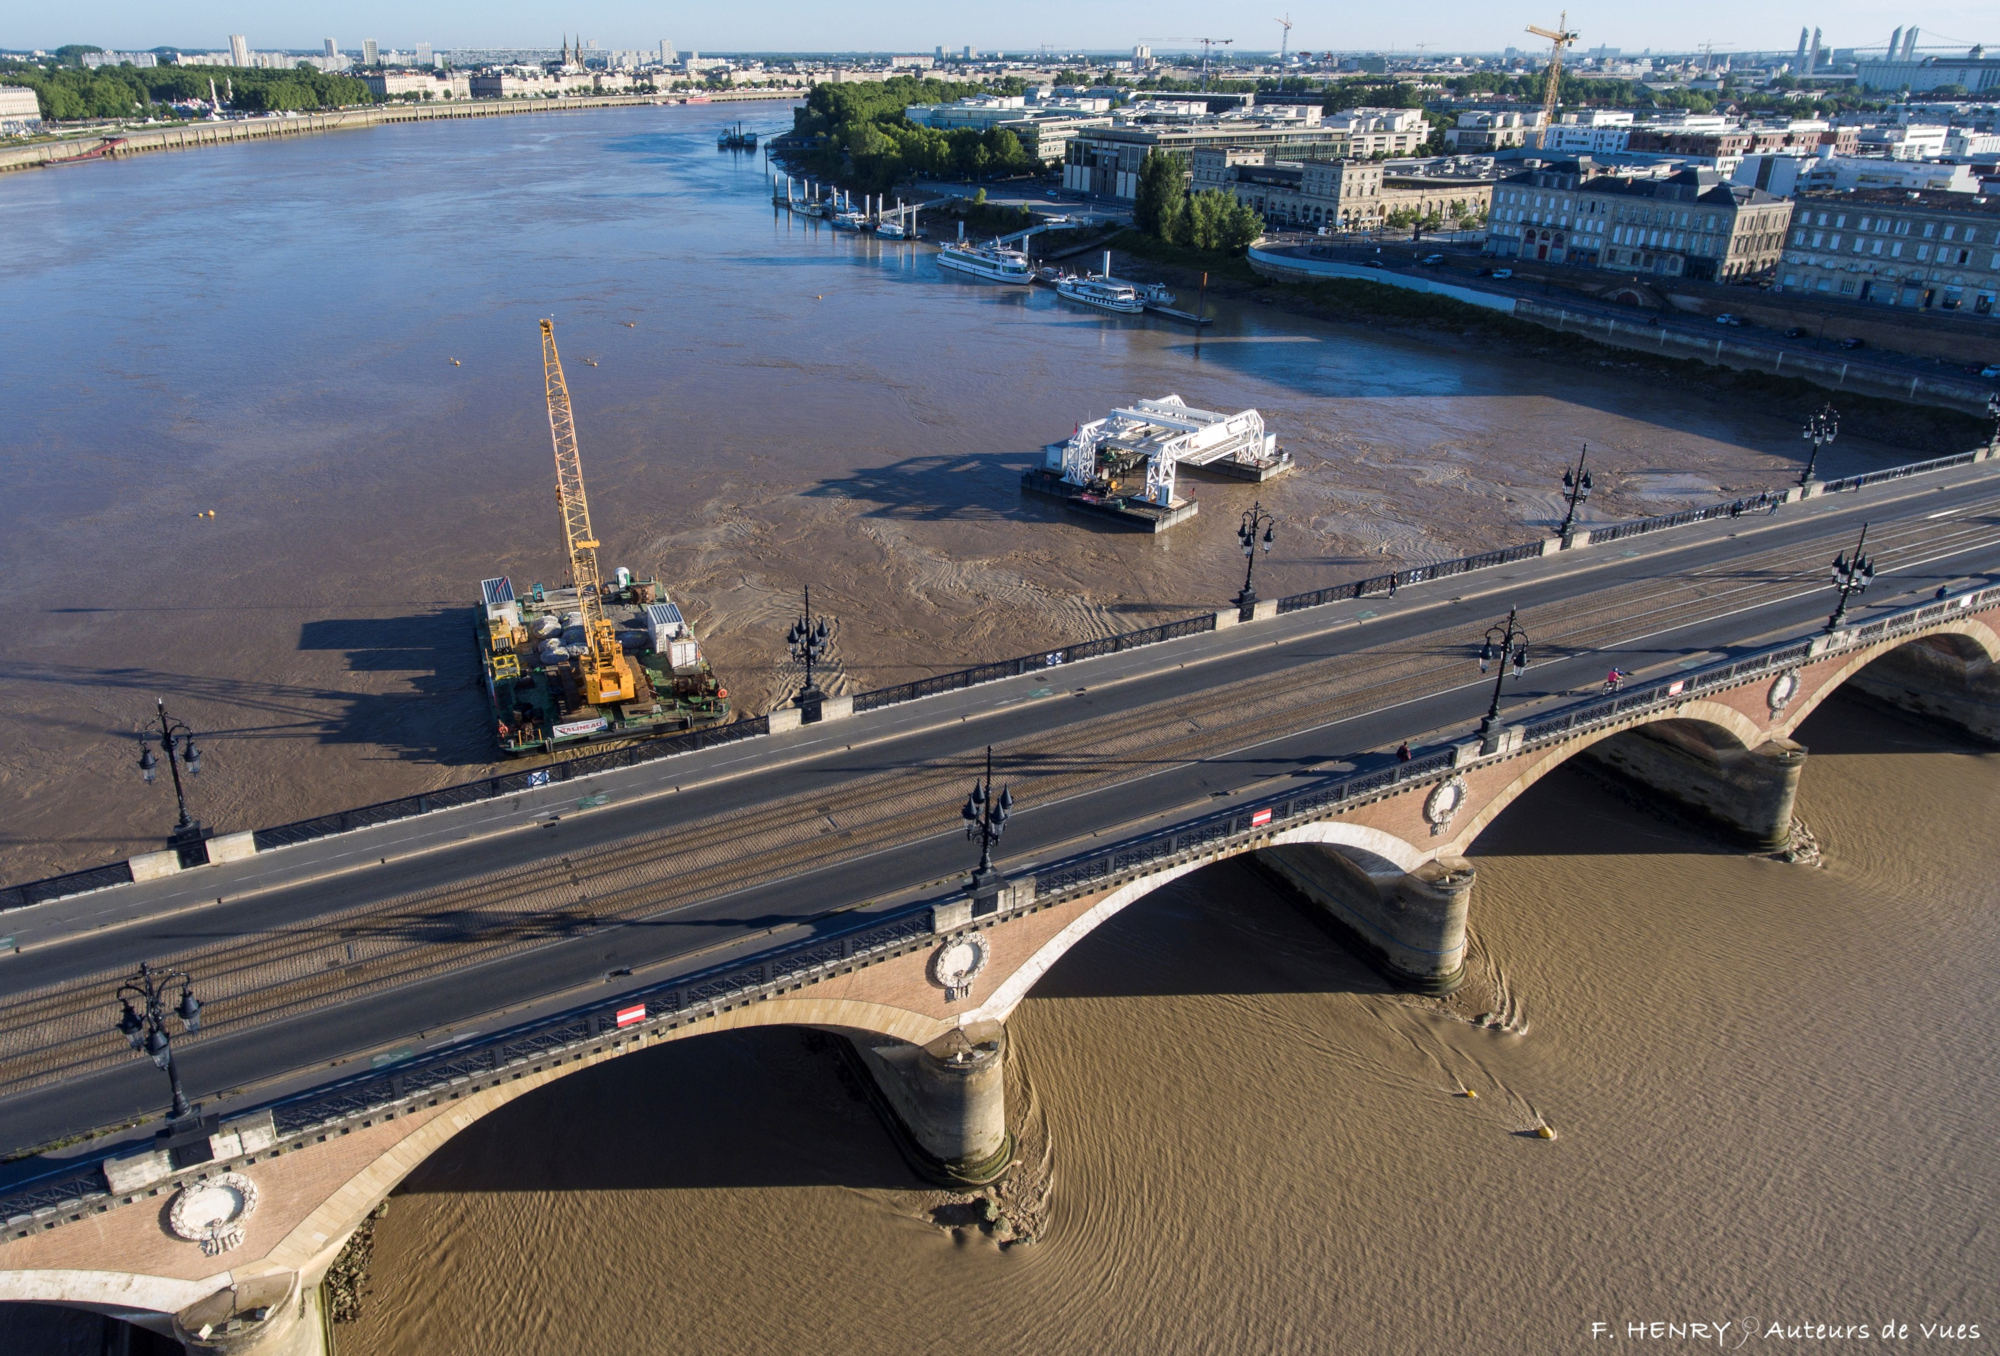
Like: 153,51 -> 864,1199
19,0 -> 2000,52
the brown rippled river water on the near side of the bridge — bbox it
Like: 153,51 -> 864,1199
316,702 -> 2000,1356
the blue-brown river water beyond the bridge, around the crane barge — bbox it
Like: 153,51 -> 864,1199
0,101 -> 1928,880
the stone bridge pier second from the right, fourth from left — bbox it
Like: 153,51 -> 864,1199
1582,720 -> 1806,852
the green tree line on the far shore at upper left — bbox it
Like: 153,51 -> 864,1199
0,62 -> 374,122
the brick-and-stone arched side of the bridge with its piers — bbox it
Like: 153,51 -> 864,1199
0,588 -> 2000,1354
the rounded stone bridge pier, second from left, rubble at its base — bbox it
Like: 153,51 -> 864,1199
854,1022 -> 1014,1186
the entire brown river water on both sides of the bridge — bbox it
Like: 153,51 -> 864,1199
0,110 -> 2000,1356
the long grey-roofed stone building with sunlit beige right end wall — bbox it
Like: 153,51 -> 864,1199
1486,160 -> 1792,282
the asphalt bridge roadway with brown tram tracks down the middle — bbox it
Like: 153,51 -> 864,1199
0,474 -> 2000,1146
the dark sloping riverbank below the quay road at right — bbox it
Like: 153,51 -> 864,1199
1110,230 -> 1990,448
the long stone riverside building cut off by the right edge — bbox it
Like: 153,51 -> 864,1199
1778,188 -> 2000,316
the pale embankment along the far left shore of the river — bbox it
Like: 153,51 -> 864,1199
0,90 -> 800,174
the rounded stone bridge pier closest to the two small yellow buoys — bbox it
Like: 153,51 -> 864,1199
1252,842 -> 1474,994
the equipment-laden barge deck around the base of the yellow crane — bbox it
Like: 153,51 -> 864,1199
474,570 -> 730,756
